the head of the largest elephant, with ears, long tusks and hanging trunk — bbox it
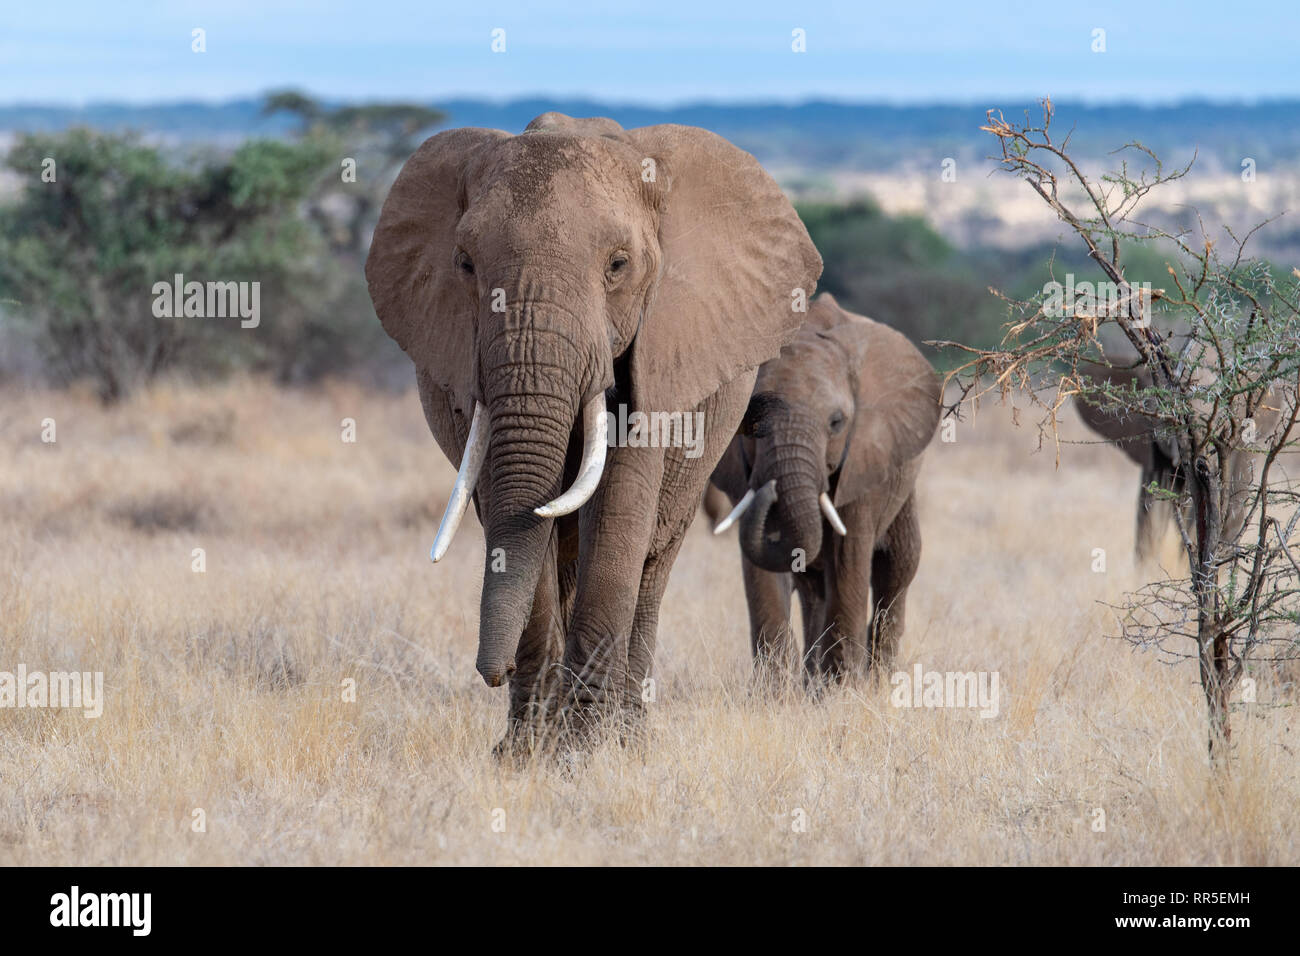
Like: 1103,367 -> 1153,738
365,113 -> 820,687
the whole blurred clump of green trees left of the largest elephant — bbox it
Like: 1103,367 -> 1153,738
0,92 -> 443,402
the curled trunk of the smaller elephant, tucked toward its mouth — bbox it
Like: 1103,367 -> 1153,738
740,429 -> 824,571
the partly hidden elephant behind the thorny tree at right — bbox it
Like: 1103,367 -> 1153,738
1075,364 -> 1278,562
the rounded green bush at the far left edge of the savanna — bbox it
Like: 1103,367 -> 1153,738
0,129 -> 340,402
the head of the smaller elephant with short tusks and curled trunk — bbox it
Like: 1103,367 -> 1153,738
714,294 -> 940,571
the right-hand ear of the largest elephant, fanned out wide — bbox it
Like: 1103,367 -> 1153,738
628,125 -> 822,411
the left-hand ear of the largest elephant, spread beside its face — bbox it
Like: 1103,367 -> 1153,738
365,127 -> 510,418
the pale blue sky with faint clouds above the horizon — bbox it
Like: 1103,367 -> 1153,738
0,0 -> 1300,105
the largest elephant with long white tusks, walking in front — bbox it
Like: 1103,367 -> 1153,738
365,113 -> 822,752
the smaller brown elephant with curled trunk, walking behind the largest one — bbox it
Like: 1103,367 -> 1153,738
712,295 -> 940,685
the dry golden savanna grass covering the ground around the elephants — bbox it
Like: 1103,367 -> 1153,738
0,381 -> 1300,865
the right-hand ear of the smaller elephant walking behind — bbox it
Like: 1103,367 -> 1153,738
827,316 -> 941,507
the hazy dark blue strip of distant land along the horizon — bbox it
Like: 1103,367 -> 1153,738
0,98 -> 1300,170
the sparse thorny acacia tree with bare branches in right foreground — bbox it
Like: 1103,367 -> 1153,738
935,100 -> 1300,766
